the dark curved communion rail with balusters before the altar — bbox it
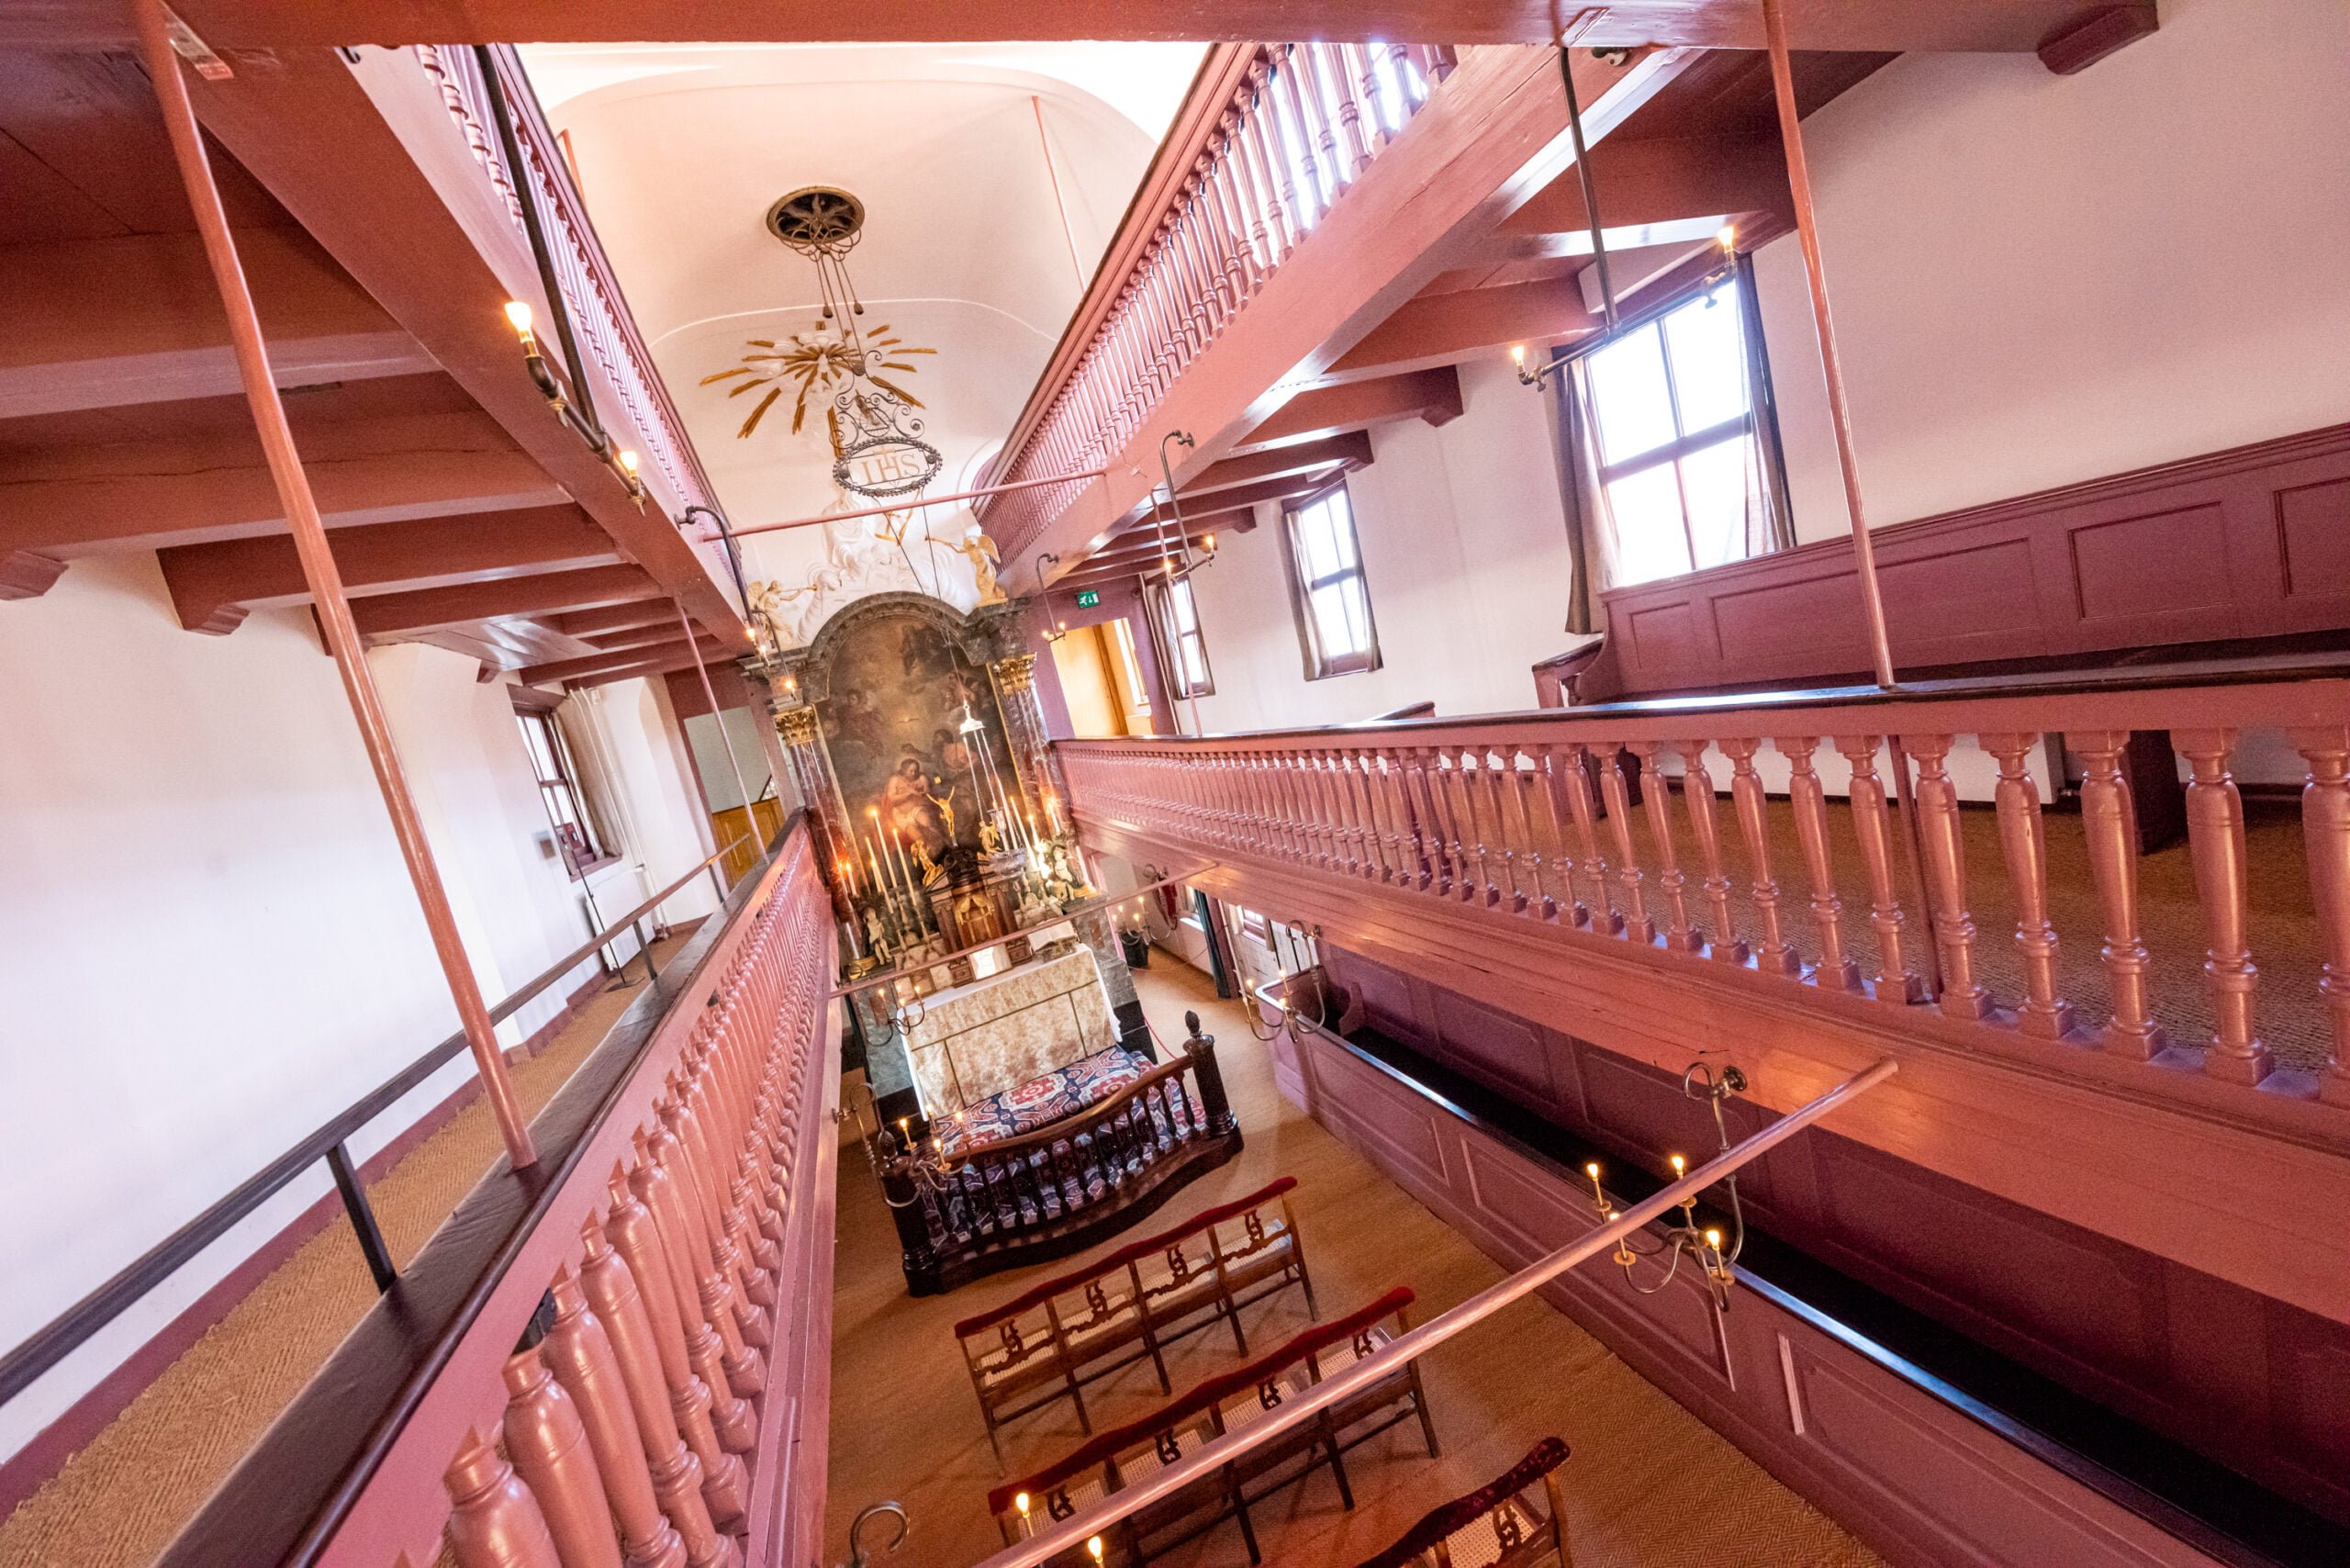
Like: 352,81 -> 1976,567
878,1032 -> 1241,1295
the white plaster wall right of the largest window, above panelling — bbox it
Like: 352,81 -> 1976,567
1755,0 -> 2350,541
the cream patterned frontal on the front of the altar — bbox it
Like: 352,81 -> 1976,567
907,947 -> 1116,1121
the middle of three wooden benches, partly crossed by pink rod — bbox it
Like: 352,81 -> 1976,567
987,1286 -> 1438,1568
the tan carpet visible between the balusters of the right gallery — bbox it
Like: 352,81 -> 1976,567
1607,799 -> 2329,1070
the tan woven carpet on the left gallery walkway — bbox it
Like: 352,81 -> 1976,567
0,938 -> 681,1568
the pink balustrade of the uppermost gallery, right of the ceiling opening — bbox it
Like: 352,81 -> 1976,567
980,42 -> 1452,557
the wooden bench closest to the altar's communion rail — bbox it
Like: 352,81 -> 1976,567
954,1175 -> 1314,1469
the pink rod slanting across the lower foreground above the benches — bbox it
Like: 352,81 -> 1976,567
980,1058 -> 1898,1568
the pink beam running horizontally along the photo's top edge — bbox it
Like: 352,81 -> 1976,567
124,0 -> 2155,54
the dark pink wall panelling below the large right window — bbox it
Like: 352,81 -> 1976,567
1579,425 -> 2350,700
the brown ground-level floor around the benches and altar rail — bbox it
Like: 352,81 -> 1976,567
825,955 -> 1877,1568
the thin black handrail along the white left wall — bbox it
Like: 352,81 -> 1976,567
0,827 -> 742,1404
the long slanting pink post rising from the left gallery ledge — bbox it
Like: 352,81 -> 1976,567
134,0 -> 538,1170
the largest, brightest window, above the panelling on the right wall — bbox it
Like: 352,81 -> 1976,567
1574,275 -> 1774,583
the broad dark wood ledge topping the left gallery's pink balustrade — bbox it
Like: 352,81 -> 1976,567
158,811 -> 806,1568
